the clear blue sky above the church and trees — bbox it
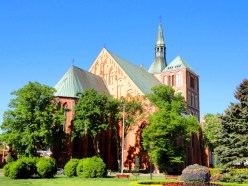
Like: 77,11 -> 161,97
0,0 -> 248,123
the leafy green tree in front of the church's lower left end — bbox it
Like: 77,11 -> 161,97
72,89 -> 108,156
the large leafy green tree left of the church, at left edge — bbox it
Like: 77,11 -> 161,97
1,82 -> 64,156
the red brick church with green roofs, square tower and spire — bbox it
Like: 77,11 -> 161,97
53,23 -> 204,169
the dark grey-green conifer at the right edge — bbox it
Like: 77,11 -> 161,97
216,79 -> 248,170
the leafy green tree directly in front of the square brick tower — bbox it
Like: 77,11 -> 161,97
142,85 -> 198,168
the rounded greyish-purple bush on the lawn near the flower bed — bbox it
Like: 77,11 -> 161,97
181,164 -> 210,184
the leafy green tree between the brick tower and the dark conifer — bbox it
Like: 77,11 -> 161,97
203,114 -> 221,151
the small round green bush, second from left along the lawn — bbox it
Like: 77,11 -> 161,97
36,158 -> 57,178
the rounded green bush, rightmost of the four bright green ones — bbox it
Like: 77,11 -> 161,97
82,156 -> 107,178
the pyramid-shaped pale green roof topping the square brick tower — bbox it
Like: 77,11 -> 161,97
163,56 -> 198,76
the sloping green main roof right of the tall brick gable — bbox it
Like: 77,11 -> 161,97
108,51 -> 160,94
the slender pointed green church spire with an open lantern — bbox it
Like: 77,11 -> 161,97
148,22 -> 167,74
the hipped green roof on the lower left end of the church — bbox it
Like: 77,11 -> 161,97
55,66 -> 109,98
